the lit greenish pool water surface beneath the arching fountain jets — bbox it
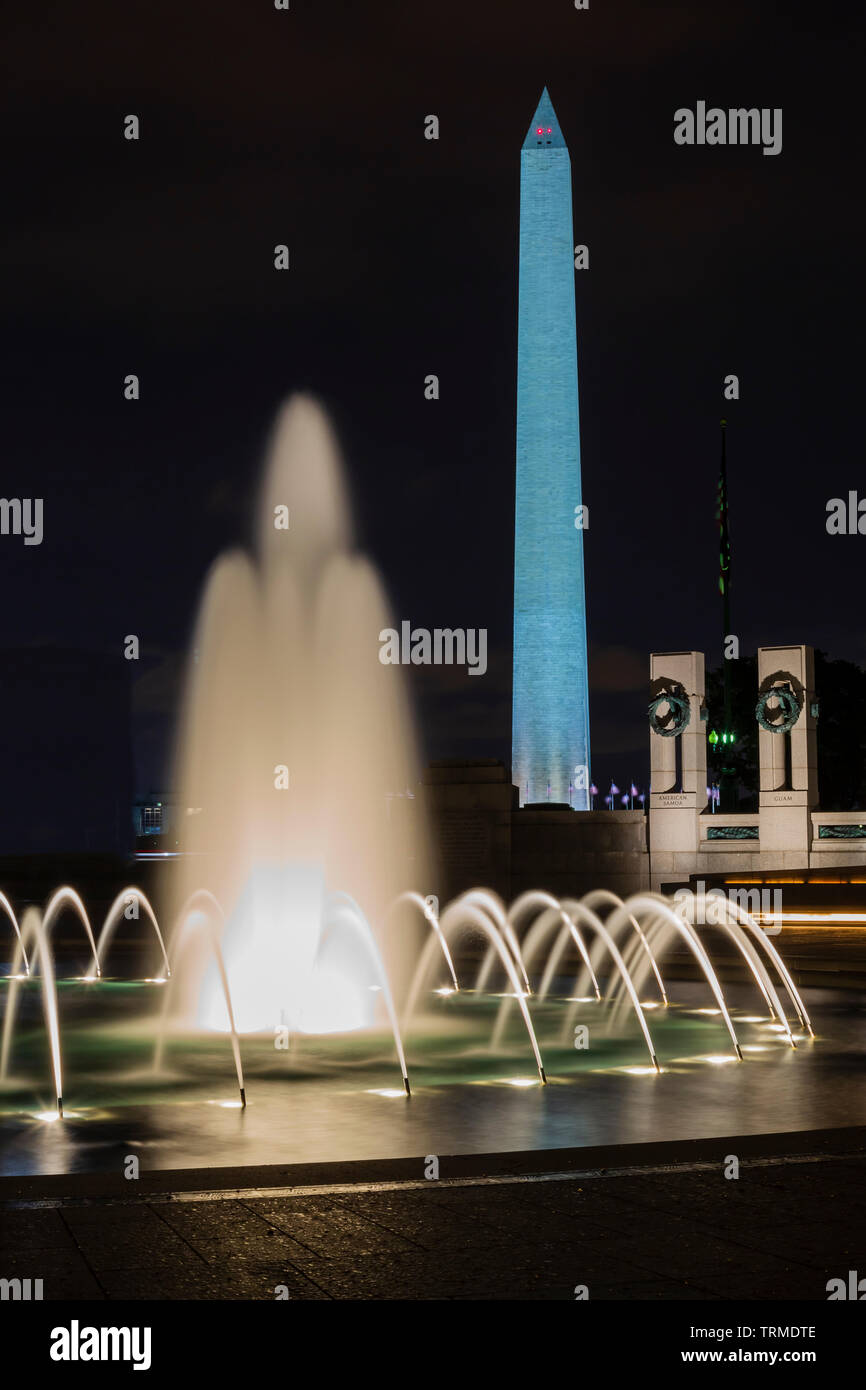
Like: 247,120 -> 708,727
0,983 -> 866,1175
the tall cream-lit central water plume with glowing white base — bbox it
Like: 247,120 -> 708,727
171,396 -> 428,1031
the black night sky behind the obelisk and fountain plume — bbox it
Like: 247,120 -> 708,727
0,0 -> 866,822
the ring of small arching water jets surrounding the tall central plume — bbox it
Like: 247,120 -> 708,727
0,887 -> 815,1113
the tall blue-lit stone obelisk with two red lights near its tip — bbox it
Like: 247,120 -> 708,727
512,88 -> 591,810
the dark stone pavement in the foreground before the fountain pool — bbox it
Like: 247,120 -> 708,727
0,1145 -> 866,1302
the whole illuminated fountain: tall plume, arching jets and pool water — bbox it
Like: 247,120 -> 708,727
0,398 -> 865,1175
